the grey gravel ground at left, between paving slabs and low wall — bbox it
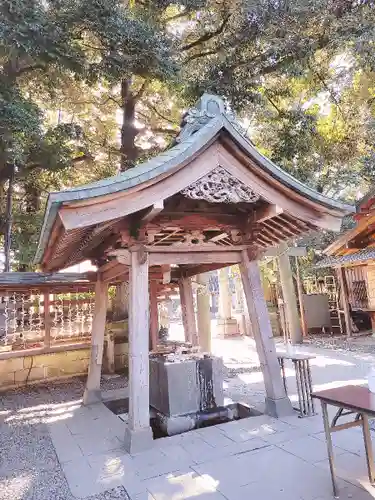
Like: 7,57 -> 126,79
0,377 -> 129,500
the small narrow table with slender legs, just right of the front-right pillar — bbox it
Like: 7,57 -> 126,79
276,352 -> 315,417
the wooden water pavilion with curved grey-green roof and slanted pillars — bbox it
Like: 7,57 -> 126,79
36,94 -> 353,449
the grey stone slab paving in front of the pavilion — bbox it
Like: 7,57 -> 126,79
48,398 -> 375,500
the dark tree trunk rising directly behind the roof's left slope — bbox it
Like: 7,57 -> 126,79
120,79 -> 138,172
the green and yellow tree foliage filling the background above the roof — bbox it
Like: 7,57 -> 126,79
0,0 -> 375,268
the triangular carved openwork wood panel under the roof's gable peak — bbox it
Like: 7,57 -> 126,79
181,167 -> 260,203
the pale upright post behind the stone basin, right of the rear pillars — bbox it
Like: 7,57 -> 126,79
197,273 -> 211,352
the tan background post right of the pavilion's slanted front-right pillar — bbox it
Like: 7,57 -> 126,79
278,252 -> 302,344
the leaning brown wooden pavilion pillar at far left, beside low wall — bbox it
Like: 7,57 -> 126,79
83,276 -> 108,405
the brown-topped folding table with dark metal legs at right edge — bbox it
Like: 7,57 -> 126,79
312,385 -> 375,498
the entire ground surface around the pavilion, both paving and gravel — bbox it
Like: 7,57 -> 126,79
0,330 -> 375,500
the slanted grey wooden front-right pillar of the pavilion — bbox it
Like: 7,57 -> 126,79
240,250 -> 293,417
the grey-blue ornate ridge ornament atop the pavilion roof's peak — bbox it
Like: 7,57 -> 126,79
176,93 -> 246,142
